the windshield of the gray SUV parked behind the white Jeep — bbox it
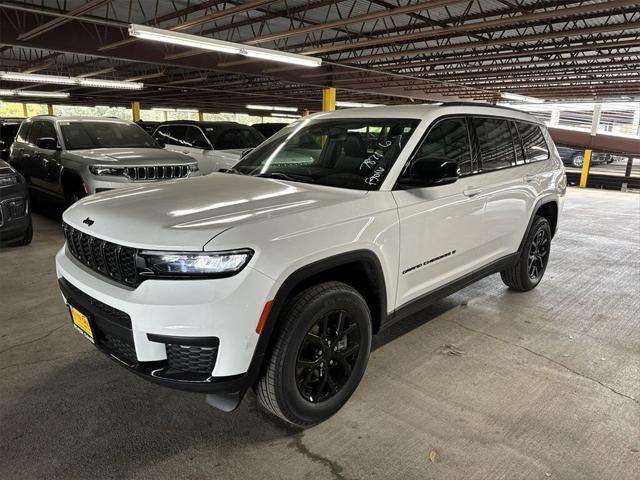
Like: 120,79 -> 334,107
59,121 -> 160,150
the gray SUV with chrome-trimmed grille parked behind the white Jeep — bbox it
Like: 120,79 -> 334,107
9,116 -> 199,205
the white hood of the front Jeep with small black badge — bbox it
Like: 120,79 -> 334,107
63,173 -> 367,251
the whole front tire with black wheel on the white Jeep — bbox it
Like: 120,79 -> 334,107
256,282 -> 372,426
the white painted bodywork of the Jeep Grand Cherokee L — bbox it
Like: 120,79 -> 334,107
56,106 -> 564,376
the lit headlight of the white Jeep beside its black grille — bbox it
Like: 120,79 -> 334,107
140,249 -> 253,277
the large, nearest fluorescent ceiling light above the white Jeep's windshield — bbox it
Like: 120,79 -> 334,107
129,24 -> 322,67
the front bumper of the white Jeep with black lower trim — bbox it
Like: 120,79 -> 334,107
56,247 -> 273,393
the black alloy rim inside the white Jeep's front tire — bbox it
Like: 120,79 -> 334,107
296,310 -> 360,403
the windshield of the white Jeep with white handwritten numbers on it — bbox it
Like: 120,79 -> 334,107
233,118 -> 420,190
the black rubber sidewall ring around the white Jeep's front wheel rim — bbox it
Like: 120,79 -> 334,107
277,290 -> 372,423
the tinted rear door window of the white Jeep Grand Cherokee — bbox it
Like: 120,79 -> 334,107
471,117 -> 516,172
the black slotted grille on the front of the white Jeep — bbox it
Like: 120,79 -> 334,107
63,223 -> 140,287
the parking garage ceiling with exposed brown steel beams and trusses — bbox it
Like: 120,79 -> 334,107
0,0 -> 640,112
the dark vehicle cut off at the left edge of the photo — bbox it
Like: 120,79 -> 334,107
0,160 -> 33,245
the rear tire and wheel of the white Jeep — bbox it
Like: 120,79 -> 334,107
500,215 -> 551,292
